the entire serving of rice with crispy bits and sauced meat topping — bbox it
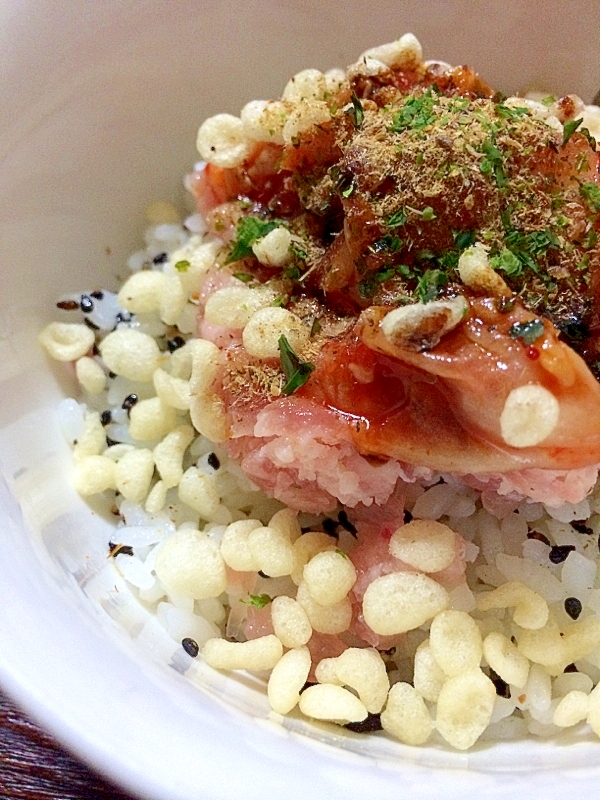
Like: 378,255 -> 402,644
40,34 -> 600,750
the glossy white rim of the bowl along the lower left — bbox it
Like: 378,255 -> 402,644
0,468 -> 600,800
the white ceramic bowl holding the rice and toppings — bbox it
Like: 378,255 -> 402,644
0,0 -> 600,800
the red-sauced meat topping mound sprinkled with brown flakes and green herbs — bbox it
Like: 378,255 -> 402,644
189,37 -> 600,510
